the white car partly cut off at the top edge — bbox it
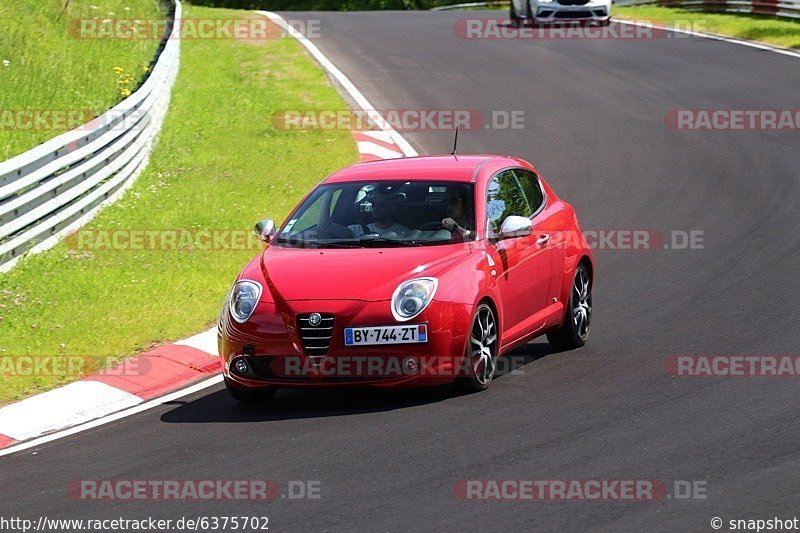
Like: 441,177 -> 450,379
509,0 -> 611,25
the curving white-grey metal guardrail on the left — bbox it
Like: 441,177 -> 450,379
0,0 -> 182,272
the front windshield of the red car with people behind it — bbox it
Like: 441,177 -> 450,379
276,180 -> 475,248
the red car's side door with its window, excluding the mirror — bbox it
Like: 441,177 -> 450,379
486,169 -> 550,342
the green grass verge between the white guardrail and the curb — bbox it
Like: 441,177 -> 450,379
0,6 -> 357,403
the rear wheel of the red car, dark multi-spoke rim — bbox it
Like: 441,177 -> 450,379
547,263 -> 592,351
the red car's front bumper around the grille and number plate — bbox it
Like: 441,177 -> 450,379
219,300 -> 472,389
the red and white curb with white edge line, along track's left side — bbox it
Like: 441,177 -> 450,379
0,11 -> 417,456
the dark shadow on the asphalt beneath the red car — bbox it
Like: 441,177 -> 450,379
161,342 -> 555,424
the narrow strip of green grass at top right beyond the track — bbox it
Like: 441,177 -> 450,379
612,6 -> 800,48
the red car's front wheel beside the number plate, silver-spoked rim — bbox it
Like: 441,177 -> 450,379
458,303 -> 499,392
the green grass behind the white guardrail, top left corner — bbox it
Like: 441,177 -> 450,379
0,0 -> 165,161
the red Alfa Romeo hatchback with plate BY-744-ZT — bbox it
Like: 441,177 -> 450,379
219,155 -> 594,402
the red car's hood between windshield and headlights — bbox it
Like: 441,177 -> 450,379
261,244 -> 471,302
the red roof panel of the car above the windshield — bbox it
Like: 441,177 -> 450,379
323,154 -> 518,183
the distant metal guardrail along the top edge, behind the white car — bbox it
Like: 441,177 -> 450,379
431,0 -> 800,19
